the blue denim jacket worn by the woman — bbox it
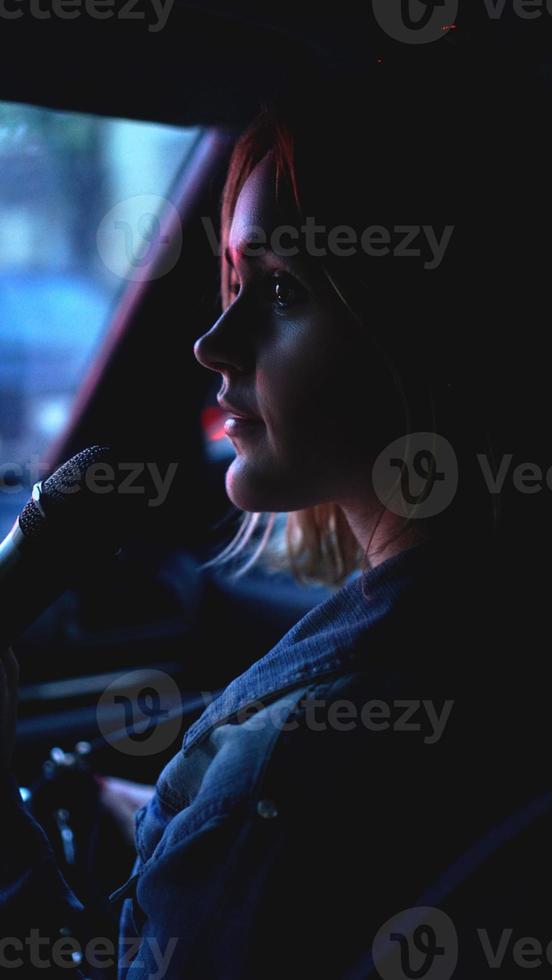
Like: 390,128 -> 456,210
0,543 -> 550,980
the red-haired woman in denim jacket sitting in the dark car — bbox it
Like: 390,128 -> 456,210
3,65 -> 547,980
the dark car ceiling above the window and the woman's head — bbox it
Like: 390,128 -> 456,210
0,0 -> 552,125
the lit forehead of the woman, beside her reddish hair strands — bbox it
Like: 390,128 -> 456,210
228,152 -> 297,252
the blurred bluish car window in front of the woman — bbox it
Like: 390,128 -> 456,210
0,102 -> 202,533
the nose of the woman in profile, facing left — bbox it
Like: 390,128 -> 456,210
194,299 -> 254,372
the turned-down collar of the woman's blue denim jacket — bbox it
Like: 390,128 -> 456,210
182,541 -> 446,753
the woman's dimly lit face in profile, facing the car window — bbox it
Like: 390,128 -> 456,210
194,153 -> 396,511
